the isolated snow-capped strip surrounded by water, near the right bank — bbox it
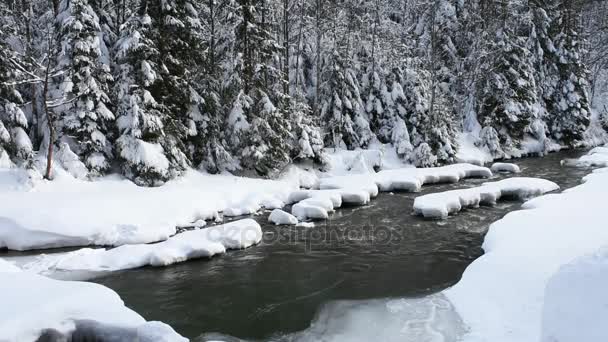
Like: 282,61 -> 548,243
414,177 -> 559,218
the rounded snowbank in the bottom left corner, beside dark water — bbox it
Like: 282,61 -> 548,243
0,264 -> 187,342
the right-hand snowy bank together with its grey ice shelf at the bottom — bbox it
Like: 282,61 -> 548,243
286,146 -> 608,342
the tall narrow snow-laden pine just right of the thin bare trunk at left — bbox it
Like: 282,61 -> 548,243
57,0 -> 115,174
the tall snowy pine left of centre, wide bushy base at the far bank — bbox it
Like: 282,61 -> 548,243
229,0 -> 291,175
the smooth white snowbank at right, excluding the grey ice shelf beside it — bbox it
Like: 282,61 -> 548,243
445,157 -> 608,342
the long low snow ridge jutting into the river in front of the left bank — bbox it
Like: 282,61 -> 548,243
24,219 -> 262,273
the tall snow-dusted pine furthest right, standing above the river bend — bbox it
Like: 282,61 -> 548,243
531,0 -> 590,146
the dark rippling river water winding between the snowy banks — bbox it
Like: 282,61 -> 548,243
94,151 -> 586,339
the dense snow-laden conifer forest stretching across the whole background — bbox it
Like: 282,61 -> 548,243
0,0 -> 608,186
